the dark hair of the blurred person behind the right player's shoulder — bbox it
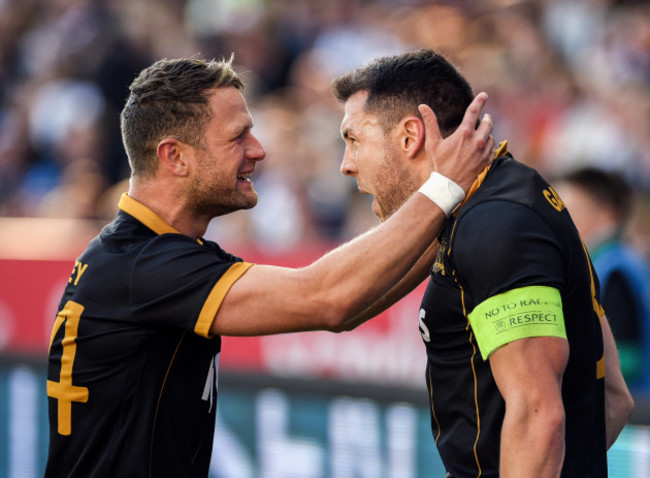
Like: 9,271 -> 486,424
561,167 -> 635,222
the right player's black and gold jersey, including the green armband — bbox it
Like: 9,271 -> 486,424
419,153 -> 607,478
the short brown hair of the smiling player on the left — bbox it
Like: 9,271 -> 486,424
120,56 -> 244,176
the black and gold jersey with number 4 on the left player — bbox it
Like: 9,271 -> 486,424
45,195 -> 251,477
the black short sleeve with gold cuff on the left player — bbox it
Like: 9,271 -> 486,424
130,234 -> 251,337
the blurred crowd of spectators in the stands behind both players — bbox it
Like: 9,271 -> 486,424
0,0 -> 650,255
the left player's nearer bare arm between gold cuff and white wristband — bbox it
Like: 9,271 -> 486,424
212,193 -> 446,335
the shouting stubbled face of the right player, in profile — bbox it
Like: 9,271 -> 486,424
341,91 -> 413,221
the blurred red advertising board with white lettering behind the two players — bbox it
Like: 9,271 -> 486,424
0,247 -> 425,385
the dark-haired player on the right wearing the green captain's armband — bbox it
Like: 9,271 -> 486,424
333,50 -> 633,478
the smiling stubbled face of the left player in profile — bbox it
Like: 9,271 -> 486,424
187,87 -> 266,218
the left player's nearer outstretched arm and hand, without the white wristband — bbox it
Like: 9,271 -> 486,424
211,94 -> 494,335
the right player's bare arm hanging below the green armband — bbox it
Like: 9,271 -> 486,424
490,337 -> 569,478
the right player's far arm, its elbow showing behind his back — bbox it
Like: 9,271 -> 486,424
601,315 -> 634,449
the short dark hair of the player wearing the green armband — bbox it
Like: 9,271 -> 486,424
332,49 -> 474,137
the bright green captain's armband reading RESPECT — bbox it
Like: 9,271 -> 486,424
469,286 -> 566,360
